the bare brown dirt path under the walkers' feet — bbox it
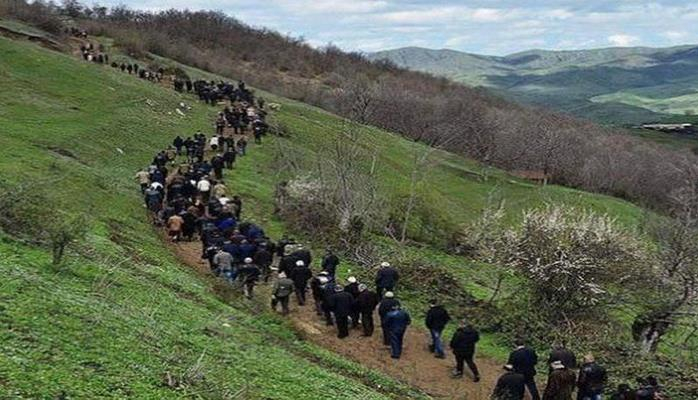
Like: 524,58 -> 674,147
172,242 -> 512,400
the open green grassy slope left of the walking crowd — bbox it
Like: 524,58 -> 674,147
0,38 -> 430,399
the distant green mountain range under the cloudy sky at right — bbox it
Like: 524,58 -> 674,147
369,45 -> 698,124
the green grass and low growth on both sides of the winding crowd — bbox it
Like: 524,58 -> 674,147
0,10 -> 695,398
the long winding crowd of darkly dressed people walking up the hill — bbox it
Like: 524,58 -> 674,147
115,36 -> 664,400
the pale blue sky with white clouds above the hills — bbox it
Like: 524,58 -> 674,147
95,0 -> 698,55
